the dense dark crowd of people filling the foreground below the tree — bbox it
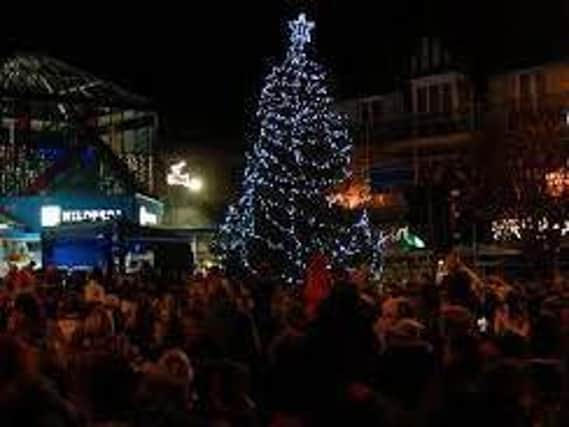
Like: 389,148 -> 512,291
0,256 -> 569,427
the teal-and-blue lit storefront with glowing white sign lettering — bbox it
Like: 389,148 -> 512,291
0,193 -> 163,269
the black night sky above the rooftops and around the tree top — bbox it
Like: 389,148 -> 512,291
0,0 -> 569,148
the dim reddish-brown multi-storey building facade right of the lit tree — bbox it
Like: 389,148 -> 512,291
340,37 -> 569,251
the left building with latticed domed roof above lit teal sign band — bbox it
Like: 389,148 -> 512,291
0,54 -> 162,270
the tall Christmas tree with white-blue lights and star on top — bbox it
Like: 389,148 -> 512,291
217,14 -> 374,281
